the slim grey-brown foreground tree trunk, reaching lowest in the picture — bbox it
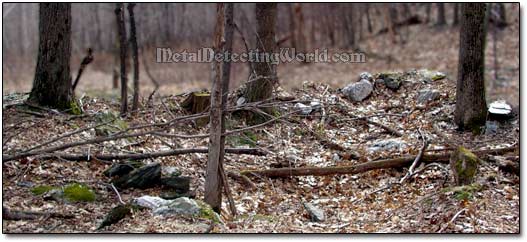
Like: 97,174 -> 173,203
205,3 -> 225,213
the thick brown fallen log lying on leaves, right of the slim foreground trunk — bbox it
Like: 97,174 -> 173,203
240,146 -> 518,177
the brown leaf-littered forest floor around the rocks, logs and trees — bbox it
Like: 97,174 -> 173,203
2,8 -> 520,233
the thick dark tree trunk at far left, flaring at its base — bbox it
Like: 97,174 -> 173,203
28,3 -> 78,112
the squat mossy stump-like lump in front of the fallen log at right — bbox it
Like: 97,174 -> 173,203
450,146 -> 479,186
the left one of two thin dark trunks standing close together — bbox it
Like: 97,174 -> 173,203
115,3 -> 128,115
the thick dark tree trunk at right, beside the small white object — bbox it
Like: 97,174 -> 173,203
454,3 -> 487,131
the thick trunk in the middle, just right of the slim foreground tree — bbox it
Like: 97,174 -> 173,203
245,3 -> 278,105
